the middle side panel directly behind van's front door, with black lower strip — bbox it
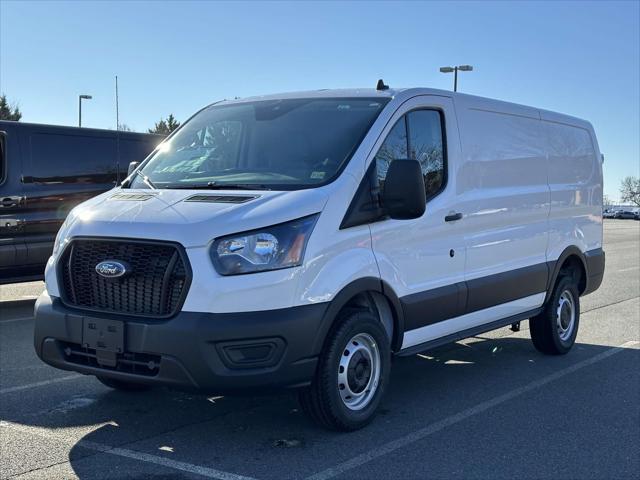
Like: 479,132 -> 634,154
456,97 -> 550,300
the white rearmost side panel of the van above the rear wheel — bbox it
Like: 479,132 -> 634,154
542,112 -> 602,261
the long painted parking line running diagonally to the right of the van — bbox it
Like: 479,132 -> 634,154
307,341 -> 640,480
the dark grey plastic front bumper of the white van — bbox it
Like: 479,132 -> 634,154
34,293 -> 328,393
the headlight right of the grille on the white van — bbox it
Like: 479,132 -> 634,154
211,215 -> 318,275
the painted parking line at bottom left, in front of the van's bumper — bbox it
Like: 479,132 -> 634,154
0,420 -> 255,480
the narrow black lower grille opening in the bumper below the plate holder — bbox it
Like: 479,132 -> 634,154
62,343 -> 160,377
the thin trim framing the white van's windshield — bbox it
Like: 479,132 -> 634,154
127,97 -> 392,191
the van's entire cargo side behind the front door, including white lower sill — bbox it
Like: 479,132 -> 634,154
402,95 -> 604,349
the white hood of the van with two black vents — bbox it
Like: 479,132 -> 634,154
61,187 -> 329,247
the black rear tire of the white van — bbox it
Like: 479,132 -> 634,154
529,275 -> 580,355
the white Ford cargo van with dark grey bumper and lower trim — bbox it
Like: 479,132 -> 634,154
35,82 -> 604,430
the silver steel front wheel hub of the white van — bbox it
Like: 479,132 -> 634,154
338,333 -> 380,410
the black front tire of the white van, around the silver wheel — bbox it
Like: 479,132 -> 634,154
298,311 -> 391,432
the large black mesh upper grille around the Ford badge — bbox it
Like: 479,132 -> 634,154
59,239 -> 190,317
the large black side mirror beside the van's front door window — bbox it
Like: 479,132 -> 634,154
382,160 -> 427,220
